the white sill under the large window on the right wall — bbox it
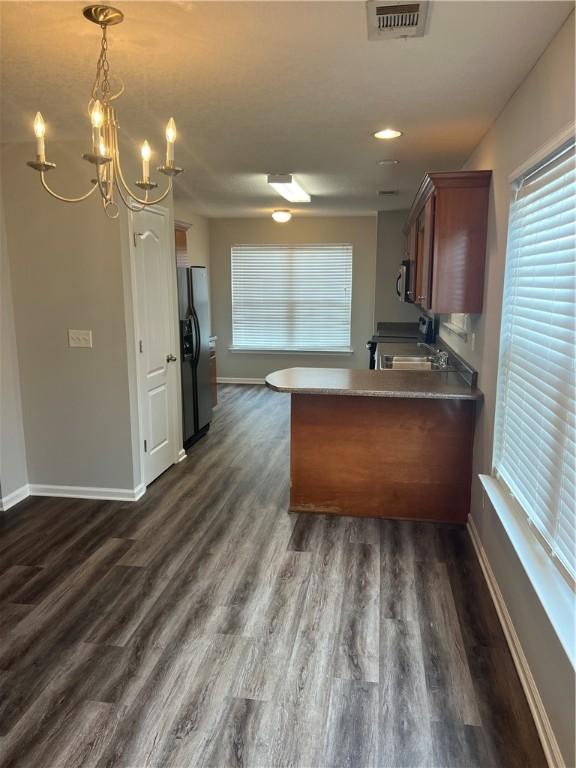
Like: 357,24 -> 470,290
479,475 -> 576,667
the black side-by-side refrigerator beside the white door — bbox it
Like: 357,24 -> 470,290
177,267 -> 212,448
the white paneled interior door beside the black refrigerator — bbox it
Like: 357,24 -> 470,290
133,209 -> 179,485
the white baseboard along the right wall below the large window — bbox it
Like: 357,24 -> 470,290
468,518 -> 566,768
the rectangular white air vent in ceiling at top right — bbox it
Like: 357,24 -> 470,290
366,0 -> 428,40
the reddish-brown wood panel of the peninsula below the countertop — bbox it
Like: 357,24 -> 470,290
290,394 -> 475,523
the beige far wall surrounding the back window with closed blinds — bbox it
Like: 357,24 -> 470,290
210,216 -> 376,379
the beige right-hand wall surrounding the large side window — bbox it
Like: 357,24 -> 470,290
446,14 -> 576,766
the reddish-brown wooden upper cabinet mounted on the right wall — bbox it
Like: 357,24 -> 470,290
406,171 -> 492,314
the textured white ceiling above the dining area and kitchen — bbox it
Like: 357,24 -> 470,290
0,0 -> 574,216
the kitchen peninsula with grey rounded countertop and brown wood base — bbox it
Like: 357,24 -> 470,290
266,368 -> 482,523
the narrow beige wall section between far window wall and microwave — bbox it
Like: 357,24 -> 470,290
374,211 -> 420,323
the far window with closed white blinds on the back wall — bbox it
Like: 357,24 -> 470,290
232,243 -> 352,352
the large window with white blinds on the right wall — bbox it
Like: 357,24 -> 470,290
494,140 -> 576,584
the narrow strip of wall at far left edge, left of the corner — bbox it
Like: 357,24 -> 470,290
0,170 -> 28,500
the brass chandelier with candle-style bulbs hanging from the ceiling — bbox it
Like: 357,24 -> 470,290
27,5 -> 183,219
